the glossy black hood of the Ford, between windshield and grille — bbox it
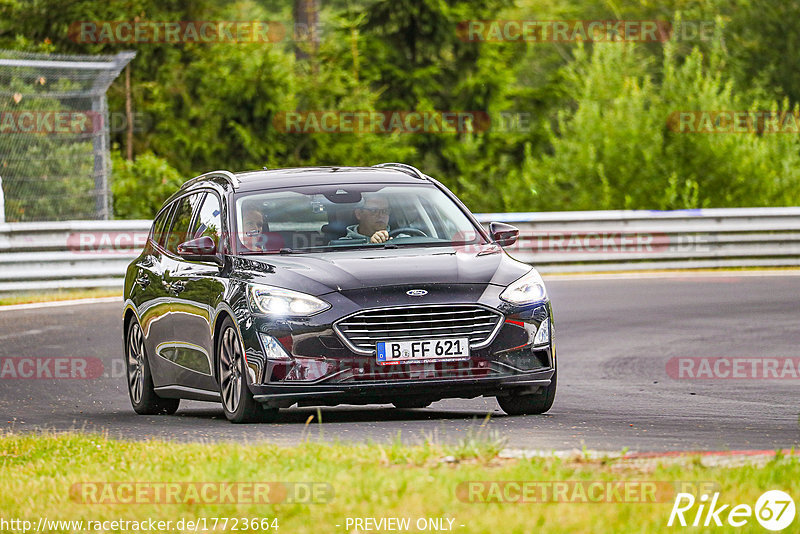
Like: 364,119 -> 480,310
235,245 -> 530,295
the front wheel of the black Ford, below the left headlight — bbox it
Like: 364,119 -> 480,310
217,317 -> 278,423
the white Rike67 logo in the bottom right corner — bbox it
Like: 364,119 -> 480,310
667,490 -> 795,531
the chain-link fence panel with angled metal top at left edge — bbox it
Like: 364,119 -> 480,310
0,50 -> 135,222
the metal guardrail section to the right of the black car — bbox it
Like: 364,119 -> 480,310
479,207 -> 800,272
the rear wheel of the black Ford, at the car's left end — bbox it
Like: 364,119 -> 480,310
125,319 -> 181,415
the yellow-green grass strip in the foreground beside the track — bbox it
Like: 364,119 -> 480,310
0,434 -> 800,534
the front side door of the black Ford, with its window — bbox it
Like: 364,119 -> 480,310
162,191 -> 224,391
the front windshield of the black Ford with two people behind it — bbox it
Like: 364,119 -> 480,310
236,184 -> 485,254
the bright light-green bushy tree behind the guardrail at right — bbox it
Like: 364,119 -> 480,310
520,40 -> 800,211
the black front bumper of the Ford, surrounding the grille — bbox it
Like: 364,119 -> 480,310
234,293 -> 556,407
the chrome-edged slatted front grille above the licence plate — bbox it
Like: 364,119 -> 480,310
336,305 -> 503,354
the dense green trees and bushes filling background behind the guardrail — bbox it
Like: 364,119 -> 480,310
0,0 -> 800,218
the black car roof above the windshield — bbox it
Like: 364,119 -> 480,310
234,167 -> 430,195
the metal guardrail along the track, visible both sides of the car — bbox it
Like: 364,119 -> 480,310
0,207 -> 800,293
